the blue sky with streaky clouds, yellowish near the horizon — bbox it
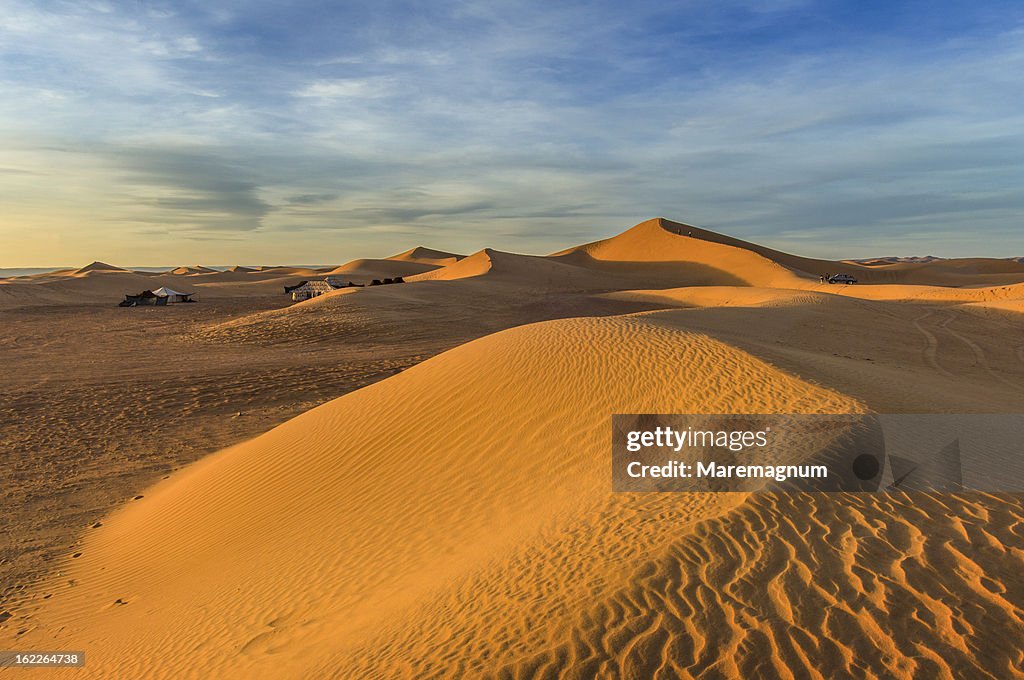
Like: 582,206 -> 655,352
0,0 -> 1024,267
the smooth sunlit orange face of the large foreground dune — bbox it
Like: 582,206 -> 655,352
25,316 -> 862,678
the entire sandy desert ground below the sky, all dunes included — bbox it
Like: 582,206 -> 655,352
0,219 -> 1024,679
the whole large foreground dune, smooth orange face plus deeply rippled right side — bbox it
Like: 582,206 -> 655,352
9,297 -> 1024,678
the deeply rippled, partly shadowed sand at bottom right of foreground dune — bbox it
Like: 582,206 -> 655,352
335,495 -> 1024,679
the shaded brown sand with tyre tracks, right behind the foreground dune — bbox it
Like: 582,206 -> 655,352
634,288 -> 1024,413
